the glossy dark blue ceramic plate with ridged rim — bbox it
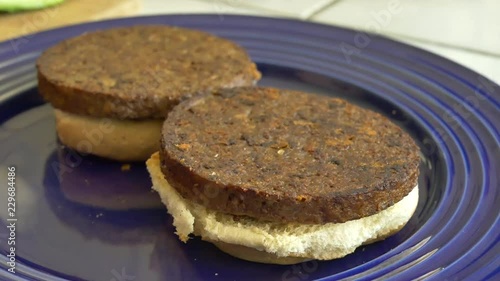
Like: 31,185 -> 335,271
0,15 -> 500,281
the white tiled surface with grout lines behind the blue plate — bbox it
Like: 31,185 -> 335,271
142,0 -> 500,84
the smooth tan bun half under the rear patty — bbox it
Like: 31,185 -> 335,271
55,109 -> 163,161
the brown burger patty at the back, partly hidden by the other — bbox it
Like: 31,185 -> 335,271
37,26 -> 260,119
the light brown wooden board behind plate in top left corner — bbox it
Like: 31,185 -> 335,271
0,0 -> 141,41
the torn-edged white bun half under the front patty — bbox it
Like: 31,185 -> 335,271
146,153 -> 418,264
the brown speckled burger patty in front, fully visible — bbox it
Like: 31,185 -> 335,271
160,87 -> 419,224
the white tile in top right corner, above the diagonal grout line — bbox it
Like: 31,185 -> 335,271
313,0 -> 500,55
